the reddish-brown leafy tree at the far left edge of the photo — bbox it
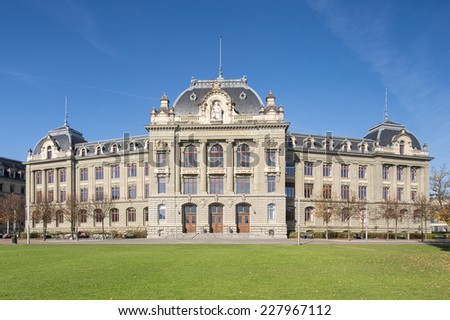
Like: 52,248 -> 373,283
0,193 -> 25,233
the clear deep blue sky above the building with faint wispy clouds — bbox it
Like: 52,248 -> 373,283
0,0 -> 450,166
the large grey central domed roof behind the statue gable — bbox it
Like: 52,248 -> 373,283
173,76 -> 263,116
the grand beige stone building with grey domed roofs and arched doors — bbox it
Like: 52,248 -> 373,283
26,76 -> 431,238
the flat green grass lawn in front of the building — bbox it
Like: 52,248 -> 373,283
0,244 -> 450,300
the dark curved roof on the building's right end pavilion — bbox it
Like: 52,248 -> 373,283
364,120 -> 422,150
